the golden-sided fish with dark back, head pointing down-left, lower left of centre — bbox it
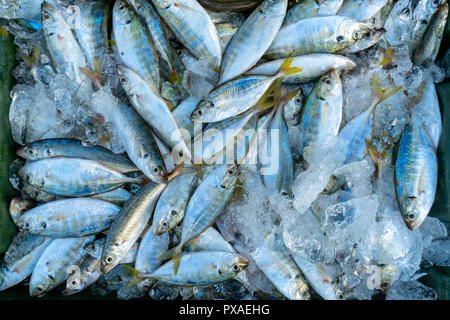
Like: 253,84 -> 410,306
101,182 -> 166,274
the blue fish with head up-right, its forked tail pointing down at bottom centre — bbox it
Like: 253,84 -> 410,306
159,164 -> 239,274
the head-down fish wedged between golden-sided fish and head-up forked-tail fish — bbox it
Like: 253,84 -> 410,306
153,172 -> 199,235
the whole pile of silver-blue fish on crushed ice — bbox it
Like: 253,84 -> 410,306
0,0 -> 450,300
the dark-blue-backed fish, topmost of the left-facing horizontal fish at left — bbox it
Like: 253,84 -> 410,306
16,138 -> 138,173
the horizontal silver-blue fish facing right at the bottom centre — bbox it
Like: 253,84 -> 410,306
140,251 -> 248,286
